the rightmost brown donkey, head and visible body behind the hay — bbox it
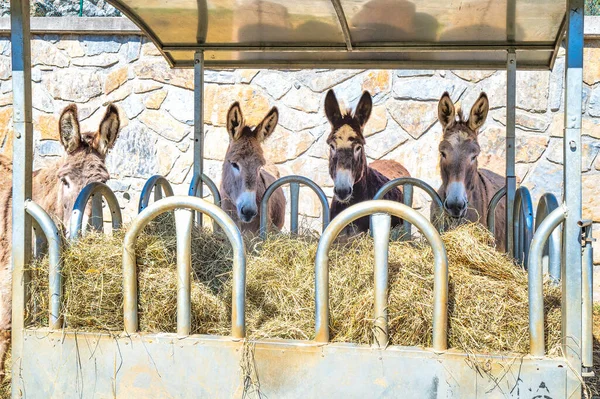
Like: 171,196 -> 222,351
431,92 -> 506,251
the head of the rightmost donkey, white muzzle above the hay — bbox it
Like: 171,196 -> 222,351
438,92 -> 489,218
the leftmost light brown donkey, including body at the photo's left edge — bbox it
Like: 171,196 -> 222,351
0,104 -> 120,378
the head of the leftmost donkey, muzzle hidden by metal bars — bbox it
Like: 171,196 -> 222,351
55,104 -> 120,227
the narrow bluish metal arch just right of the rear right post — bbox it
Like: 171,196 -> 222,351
513,186 -> 533,265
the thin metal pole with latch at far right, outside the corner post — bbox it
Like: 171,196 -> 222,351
580,220 -> 594,375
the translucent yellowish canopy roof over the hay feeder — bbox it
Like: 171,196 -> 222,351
108,0 -> 566,69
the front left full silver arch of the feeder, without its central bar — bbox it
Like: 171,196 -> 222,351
123,196 -> 246,339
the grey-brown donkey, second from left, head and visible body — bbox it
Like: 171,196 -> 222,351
219,101 -> 285,235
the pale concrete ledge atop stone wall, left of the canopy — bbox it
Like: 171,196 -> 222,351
0,17 -> 142,36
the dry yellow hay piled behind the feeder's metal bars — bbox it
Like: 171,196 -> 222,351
28,220 -> 560,355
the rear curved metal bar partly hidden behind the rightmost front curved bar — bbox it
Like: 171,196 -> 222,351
535,193 -> 562,283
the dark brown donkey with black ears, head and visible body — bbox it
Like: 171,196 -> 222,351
325,90 -> 410,232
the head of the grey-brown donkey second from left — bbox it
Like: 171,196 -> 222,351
221,102 -> 279,223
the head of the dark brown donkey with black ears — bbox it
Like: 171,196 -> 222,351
325,90 -> 373,202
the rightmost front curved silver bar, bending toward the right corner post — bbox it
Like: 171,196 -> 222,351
528,205 -> 567,357
